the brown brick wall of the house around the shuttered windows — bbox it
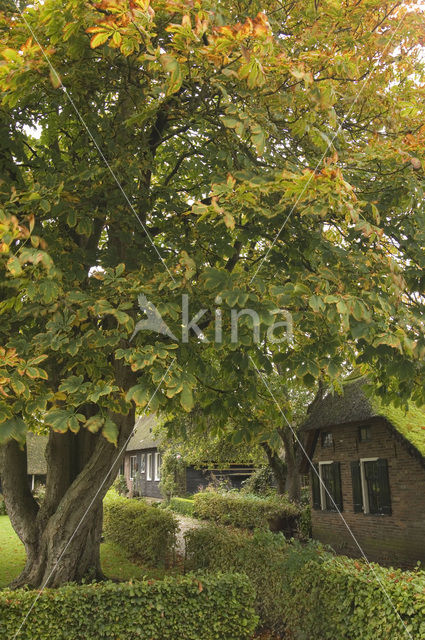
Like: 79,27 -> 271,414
312,421 -> 425,566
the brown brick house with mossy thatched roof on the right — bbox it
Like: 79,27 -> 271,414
302,378 -> 425,566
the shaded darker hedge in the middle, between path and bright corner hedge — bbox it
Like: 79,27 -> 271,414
185,524 -> 288,634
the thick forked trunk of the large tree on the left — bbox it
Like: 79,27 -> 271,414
0,412 -> 134,588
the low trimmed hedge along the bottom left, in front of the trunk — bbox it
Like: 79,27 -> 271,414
0,574 -> 257,640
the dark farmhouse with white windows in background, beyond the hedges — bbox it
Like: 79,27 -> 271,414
121,414 -> 254,498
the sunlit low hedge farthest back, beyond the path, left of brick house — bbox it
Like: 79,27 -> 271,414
193,491 -> 300,535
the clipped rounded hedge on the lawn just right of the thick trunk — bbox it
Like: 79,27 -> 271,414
104,492 -> 178,567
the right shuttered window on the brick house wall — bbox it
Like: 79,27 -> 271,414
351,458 -> 391,515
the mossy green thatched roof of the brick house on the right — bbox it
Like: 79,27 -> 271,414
301,377 -> 425,459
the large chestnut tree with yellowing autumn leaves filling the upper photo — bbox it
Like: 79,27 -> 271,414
0,0 -> 425,587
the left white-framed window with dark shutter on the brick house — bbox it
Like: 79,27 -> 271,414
311,461 -> 343,511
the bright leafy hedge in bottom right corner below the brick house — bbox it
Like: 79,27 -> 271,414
282,552 -> 425,640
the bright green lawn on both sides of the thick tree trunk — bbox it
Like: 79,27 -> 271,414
0,516 -> 164,589
